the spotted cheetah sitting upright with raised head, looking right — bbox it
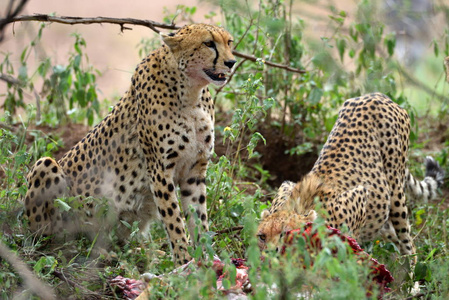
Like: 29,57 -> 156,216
25,24 -> 236,264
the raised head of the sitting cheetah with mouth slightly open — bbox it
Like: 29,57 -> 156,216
161,24 -> 236,86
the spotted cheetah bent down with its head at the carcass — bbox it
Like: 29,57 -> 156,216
257,93 -> 444,254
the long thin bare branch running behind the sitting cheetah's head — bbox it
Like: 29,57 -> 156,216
0,14 -> 306,74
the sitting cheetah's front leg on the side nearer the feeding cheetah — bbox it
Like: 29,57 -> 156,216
179,159 -> 209,243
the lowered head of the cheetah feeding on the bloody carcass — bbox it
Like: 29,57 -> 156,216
257,210 -> 317,250
